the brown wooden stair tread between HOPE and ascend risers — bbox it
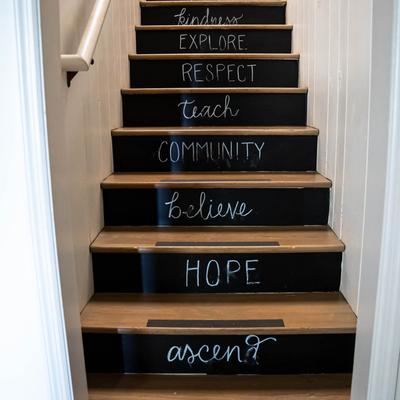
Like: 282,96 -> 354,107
81,292 -> 356,335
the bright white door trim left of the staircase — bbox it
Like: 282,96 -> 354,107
0,0 -> 73,400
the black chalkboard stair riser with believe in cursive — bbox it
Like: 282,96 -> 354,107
103,188 -> 329,226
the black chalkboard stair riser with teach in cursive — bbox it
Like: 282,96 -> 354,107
122,89 -> 307,127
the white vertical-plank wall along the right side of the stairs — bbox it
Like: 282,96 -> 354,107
288,0 -> 372,312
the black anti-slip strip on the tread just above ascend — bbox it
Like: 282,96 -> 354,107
147,319 -> 285,328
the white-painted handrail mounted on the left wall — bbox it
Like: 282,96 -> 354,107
61,0 -> 111,86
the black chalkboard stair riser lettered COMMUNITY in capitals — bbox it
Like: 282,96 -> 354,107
112,134 -> 318,173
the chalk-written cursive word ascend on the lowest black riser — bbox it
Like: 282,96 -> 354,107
167,335 -> 278,365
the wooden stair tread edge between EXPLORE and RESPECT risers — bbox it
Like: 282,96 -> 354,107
129,53 -> 300,60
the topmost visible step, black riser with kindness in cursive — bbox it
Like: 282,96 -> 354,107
140,1 -> 286,25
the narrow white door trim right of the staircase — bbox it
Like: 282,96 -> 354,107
368,1 -> 400,400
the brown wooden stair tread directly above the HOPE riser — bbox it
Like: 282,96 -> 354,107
91,227 -> 344,253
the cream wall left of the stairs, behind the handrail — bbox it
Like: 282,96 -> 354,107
40,0 -> 135,400
